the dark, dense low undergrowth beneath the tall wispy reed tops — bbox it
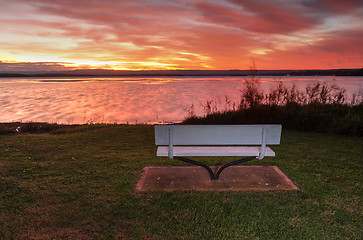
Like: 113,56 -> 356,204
183,103 -> 363,136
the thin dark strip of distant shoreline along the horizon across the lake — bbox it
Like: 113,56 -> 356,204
0,68 -> 363,78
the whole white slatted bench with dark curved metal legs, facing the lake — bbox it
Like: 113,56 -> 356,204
155,124 -> 282,180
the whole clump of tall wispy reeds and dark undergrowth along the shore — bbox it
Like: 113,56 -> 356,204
183,76 -> 363,136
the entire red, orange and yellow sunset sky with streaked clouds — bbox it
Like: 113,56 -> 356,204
0,0 -> 363,72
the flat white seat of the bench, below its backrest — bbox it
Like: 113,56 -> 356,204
157,146 -> 275,157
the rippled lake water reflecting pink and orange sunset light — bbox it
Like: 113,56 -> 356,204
0,76 -> 363,124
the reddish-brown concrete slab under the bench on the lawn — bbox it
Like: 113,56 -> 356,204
136,166 -> 298,191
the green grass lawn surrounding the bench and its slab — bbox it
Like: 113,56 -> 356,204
0,125 -> 363,239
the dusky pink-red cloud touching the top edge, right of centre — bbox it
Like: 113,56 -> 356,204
197,0 -> 319,34
